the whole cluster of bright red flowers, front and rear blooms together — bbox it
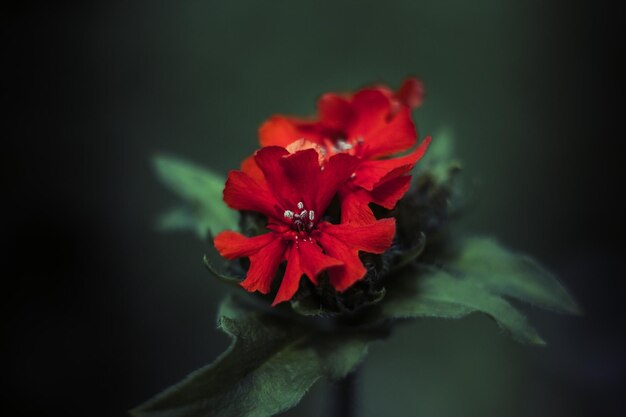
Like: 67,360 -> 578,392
214,78 -> 430,305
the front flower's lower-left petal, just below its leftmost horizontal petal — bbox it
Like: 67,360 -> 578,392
241,237 -> 289,294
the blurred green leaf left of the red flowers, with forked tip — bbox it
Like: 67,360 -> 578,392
153,155 -> 237,239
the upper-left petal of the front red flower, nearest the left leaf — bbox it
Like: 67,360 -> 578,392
224,171 -> 278,218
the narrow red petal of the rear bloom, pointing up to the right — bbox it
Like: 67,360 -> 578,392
353,136 -> 431,190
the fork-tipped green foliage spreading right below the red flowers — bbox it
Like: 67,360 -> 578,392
383,238 -> 579,344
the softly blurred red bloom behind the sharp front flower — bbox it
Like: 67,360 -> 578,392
254,78 -> 431,224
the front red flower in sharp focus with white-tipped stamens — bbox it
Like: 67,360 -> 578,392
214,146 -> 395,305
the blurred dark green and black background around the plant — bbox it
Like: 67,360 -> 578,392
0,0 -> 626,417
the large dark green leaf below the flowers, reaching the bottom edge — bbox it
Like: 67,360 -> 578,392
131,298 -> 372,417
